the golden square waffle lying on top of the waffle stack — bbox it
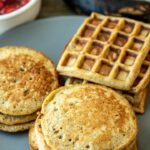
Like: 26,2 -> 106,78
57,13 -> 150,93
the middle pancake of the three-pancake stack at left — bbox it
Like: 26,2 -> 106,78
0,112 -> 37,125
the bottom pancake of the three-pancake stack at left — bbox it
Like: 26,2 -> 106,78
0,121 -> 34,132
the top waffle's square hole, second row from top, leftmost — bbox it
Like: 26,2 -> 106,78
81,25 -> 95,37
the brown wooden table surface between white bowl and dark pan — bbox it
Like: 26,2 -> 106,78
38,0 -> 76,19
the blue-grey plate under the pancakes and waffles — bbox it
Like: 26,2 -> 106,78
0,16 -> 150,150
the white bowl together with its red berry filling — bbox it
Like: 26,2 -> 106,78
0,0 -> 41,34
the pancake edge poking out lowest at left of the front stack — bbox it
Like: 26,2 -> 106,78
29,126 -> 38,150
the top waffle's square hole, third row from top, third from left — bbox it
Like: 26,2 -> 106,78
106,47 -> 120,62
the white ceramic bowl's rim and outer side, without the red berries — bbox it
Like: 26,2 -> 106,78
0,0 -> 41,34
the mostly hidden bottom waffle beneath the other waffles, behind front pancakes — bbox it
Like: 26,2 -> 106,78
65,78 -> 147,113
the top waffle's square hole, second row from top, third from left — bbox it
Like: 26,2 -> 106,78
114,33 -> 128,46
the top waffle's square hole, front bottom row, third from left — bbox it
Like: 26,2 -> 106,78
99,62 -> 113,76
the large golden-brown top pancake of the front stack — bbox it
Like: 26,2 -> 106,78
41,84 -> 138,150
